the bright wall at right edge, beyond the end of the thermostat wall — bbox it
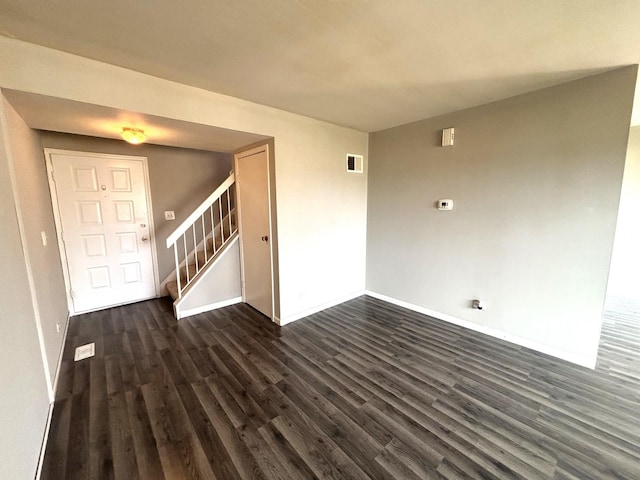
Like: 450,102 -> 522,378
607,127 -> 640,299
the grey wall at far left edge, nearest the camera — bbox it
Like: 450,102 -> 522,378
0,92 -> 49,480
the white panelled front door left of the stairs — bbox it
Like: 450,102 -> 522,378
48,152 -> 156,313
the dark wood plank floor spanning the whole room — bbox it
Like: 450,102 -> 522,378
42,297 -> 640,480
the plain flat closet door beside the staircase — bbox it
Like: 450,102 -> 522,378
235,147 -> 273,319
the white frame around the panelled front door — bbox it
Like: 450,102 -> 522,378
44,148 -> 160,315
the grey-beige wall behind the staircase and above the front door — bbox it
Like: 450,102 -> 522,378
40,132 -> 231,281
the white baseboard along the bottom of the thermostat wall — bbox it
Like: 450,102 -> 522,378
364,290 -> 597,370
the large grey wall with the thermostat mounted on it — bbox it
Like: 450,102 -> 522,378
367,66 -> 637,366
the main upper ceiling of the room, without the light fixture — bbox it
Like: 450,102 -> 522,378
0,0 -> 640,132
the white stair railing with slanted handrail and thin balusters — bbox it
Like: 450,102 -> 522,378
167,172 -> 237,298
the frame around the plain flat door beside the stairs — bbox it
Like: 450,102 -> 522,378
233,143 -> 277,323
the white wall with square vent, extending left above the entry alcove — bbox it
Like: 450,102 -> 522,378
0,38 -> 368,322
